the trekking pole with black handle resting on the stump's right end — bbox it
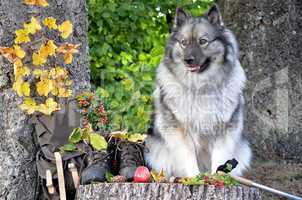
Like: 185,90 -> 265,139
217,159 -> 302,200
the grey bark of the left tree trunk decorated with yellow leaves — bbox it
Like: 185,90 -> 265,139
0,0 -> 90,200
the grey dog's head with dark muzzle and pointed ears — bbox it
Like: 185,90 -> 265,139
167,5 -> 226,73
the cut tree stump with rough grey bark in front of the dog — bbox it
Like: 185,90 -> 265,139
76,183 -> 261,200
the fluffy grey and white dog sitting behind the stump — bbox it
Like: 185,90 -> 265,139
145,5 -> 252,177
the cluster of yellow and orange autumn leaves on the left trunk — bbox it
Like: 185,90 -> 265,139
0,0 -> 80,115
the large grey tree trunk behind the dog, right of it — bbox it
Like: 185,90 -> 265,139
218,0 -> 302,162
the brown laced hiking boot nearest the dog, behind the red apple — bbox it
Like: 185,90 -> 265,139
118,141 -> 145,180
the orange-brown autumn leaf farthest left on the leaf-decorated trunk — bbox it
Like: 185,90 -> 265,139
0,45 -> 26,63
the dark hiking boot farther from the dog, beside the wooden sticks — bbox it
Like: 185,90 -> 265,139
81,151 -> 109,185
